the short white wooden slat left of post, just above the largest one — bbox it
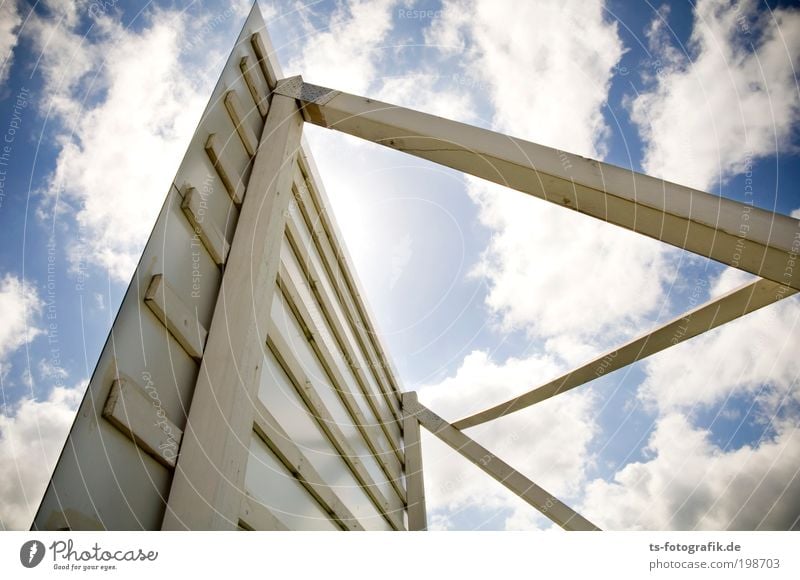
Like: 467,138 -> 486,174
144,274 -> 208,361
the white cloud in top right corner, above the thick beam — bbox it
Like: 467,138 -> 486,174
631,0 -> 800,189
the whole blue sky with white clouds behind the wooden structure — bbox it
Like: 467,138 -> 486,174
0,0 -> 800,529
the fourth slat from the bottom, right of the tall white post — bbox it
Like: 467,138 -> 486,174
278,266 -> 406,501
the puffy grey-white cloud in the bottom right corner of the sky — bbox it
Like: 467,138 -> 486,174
582,414 -> 800,530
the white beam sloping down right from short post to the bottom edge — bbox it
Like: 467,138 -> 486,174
404,398 -> 600,531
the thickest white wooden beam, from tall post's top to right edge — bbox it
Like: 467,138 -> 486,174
275,77 -> 800,290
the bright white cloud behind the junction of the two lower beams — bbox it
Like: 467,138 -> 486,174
419,351 -> 596,529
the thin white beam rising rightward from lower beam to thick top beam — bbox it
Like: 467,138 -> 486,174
453,279 -> 795,429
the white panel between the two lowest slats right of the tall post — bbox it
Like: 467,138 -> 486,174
245,433 -> 340,530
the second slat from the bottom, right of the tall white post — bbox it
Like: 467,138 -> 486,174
253,398 -> 364,530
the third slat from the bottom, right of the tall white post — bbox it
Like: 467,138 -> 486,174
267,325 -> 405,530
